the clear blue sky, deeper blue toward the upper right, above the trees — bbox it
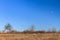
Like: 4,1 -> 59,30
0,0 -> 60,31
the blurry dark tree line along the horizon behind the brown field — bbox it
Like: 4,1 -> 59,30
2,23 -> 60,33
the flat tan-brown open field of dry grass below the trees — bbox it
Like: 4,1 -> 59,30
0,33 -> 60,40
